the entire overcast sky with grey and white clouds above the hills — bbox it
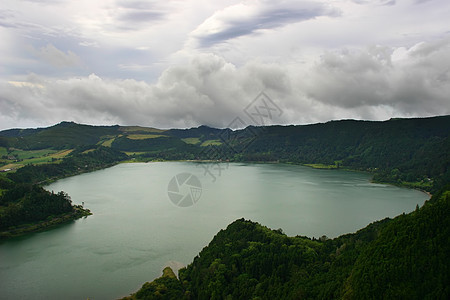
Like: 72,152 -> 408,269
0,0 -> 450,130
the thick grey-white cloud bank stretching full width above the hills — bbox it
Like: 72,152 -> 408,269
0,39 -> 450,128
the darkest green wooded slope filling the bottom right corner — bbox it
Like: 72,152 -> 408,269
345,186 -> 450,299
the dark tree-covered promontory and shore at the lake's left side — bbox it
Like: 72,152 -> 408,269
0,147 -> 127,230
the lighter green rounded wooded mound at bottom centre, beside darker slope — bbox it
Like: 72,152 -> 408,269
180,219 -> 354,299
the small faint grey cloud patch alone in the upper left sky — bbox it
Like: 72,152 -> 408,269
32,44 -> 81,68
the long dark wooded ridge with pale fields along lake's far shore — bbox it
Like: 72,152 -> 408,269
0,116 -> 450,190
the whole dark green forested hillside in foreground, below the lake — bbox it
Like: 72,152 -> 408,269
127,185 -> 450,299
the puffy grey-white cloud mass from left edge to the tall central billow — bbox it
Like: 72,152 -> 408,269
0,54 -> 281,128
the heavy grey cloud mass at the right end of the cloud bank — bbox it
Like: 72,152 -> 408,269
304,38 -> 450,115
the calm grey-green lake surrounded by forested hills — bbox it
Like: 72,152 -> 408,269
0,162 -> 428,299
